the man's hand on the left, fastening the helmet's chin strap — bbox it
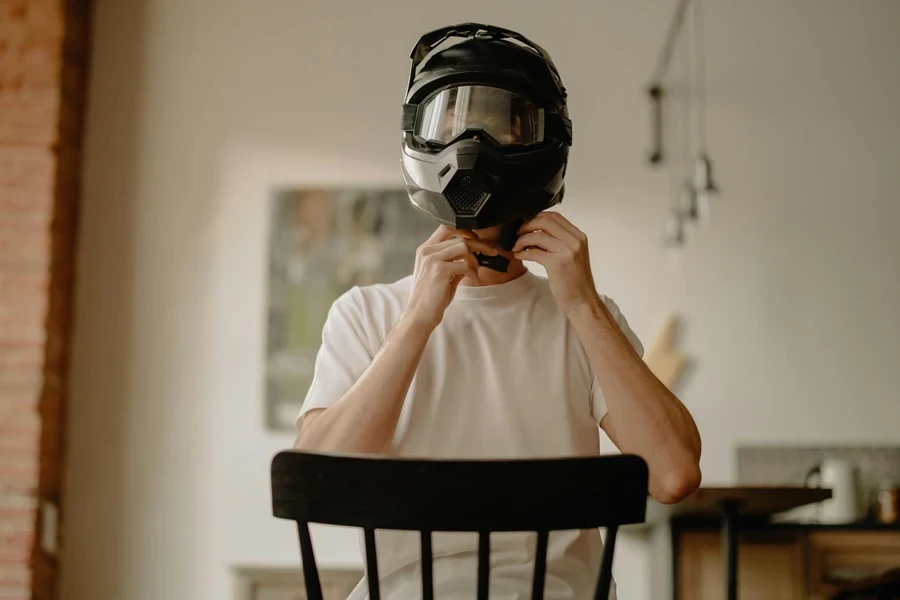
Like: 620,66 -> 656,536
403,225 -> 498,328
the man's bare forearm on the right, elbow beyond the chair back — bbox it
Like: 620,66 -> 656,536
569,299 -> 700,502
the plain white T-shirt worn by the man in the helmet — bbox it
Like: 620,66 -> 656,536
297,272 -> 643,600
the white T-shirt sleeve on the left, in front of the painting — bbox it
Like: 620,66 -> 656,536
297,287 -> 374,431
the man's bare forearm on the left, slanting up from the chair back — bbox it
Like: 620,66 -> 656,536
294,320 -> 432,454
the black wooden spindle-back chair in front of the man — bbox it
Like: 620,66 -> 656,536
272,451 -> 648,600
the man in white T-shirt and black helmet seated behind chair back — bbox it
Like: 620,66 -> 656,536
296,24 -> 700,600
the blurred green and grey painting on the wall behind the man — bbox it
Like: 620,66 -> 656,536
265,188 -> 435,431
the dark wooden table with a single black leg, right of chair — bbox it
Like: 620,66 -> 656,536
662,486 -> 831,600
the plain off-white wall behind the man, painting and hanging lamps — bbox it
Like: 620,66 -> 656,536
63,0 -> 900,600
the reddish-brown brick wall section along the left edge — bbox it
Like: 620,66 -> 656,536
0,0 -> 89,600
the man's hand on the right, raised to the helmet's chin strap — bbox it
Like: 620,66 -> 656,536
513,212 -> 602,316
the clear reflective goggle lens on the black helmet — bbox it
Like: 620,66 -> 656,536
413,85 -> 544,146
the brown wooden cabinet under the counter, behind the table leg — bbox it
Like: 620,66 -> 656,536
673,526 -> 900,600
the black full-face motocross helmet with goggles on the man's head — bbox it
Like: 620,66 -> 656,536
401,23 -> 572,270
